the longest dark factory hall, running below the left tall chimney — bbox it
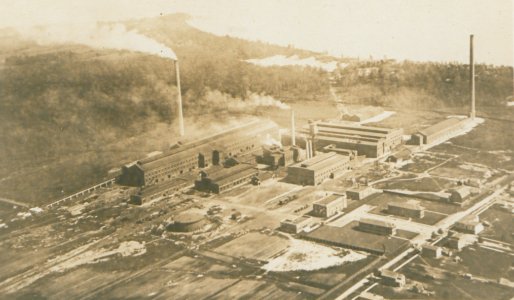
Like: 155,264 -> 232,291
117,120 -> 278,186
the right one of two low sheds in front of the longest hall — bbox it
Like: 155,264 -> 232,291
195,164 -> 259,194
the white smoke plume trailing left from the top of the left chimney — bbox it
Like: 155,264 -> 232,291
18,23 -> 177,60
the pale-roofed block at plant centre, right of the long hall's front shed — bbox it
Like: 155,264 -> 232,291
287,152 -> 350,185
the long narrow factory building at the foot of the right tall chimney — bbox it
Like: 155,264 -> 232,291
412,118 -> 468,145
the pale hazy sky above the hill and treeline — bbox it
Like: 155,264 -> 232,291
0,0 -> 514,66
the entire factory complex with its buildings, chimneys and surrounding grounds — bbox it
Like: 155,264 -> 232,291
0,32 -> 514,299
